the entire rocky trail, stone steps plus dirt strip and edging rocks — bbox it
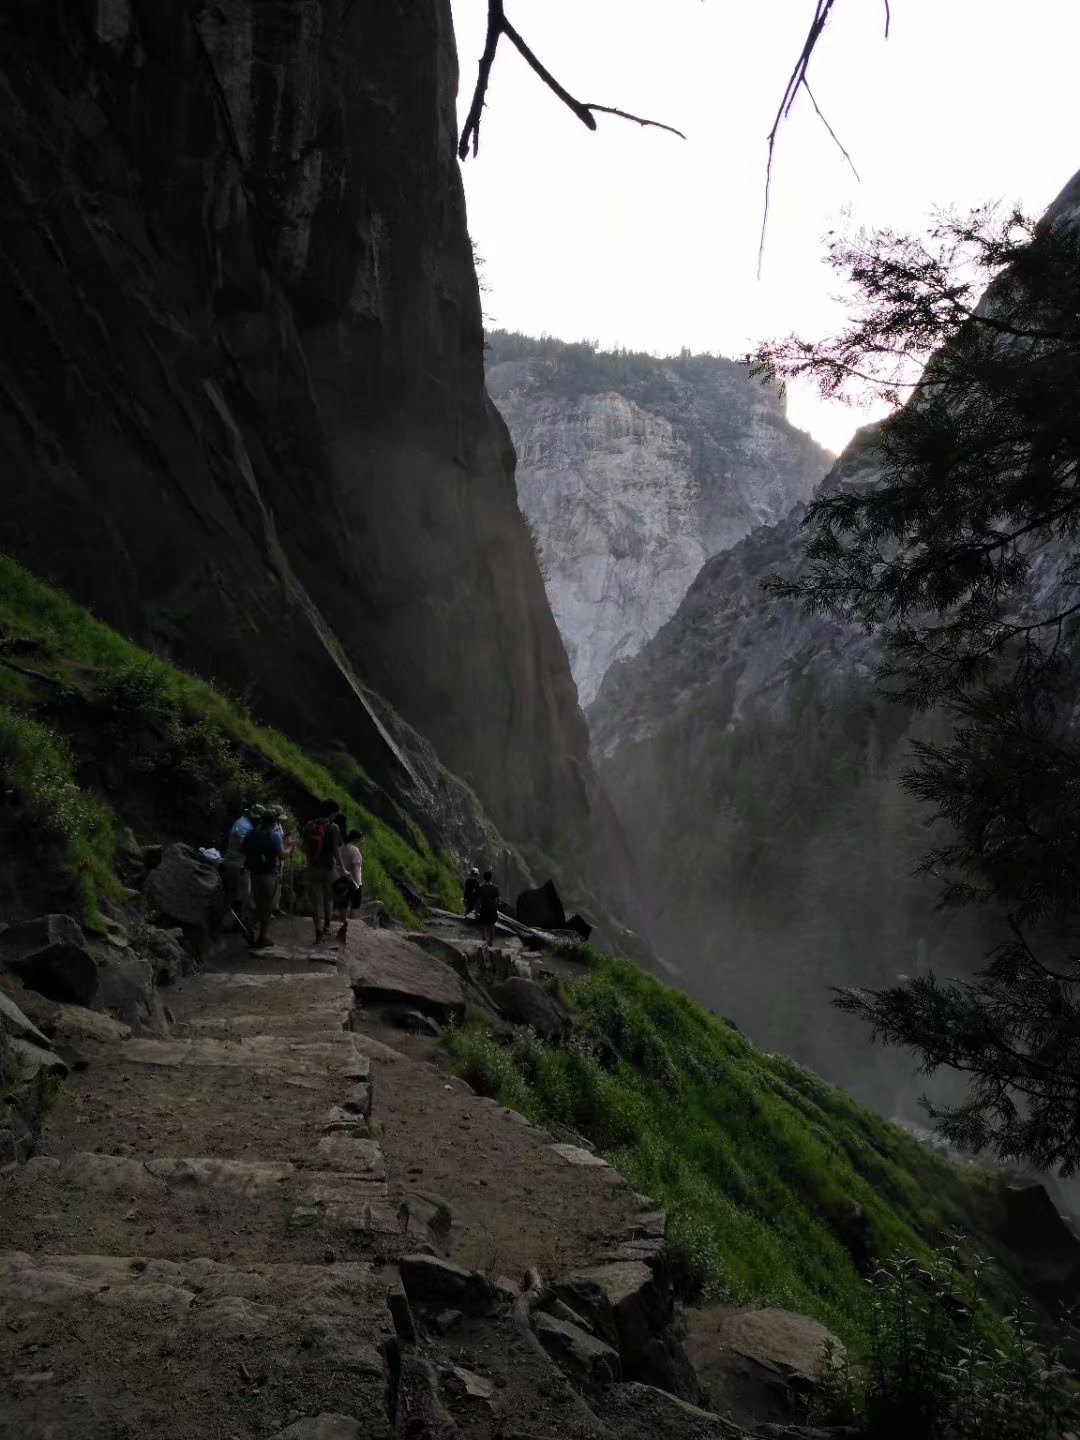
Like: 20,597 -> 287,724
0,922 -> 766,1440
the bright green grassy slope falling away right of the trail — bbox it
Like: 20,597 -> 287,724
448,950 -> 1025,1349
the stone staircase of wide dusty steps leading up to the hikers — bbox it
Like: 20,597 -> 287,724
0,958 -> 402,1440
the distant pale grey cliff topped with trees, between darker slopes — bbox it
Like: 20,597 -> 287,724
488,331 -> 831,704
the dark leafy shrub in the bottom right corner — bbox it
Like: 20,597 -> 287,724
827,1244 -> 1080,1440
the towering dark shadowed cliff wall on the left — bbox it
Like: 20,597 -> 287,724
0,0 -> 639,921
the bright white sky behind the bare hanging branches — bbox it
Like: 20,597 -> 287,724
454,0 -> 1080,449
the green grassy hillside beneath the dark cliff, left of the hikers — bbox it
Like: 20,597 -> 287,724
0,556 -> 458,926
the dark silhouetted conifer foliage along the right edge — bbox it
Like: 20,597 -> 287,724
752,194 -> 1080,1174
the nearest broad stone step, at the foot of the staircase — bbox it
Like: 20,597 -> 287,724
0,1251 -> 396,1440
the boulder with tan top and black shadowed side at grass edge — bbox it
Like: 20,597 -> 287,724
556,1260 -> 701,1403
